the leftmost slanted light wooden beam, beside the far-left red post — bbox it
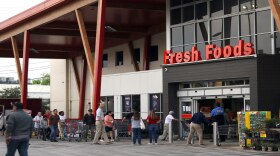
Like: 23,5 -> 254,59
11,37 -> 22,89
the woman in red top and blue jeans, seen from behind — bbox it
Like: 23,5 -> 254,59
147,110 -> 160,145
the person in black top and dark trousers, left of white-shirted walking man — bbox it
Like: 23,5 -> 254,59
83,109 -> 95,142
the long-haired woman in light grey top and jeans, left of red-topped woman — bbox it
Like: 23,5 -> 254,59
131,111 -> 142,145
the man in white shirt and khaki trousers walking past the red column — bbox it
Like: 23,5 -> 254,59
93,102 -> 112,145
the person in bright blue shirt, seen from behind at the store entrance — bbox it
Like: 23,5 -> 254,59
210,102 -> 226,142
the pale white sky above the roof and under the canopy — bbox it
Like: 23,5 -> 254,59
0,0 -> 50,80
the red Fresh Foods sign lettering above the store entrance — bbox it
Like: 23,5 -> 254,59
164,40 -> 255,64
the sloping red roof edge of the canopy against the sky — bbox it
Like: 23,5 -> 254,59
0,0 -> 69,31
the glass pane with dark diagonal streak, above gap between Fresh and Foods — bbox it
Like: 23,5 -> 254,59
196,22 -> 208,42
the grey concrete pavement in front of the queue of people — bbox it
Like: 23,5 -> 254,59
0,136 -> 280,156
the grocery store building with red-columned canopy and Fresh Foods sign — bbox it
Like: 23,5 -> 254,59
0,0 -> 280,136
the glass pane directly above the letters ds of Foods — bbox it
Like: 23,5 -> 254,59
240,13 -> 254,36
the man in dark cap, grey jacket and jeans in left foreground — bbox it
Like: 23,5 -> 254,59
6,102 -> 33,156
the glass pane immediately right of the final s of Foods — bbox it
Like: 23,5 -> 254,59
257,34 -> 272,54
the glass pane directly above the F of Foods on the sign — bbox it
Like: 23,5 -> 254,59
211,19 -> 223,40
